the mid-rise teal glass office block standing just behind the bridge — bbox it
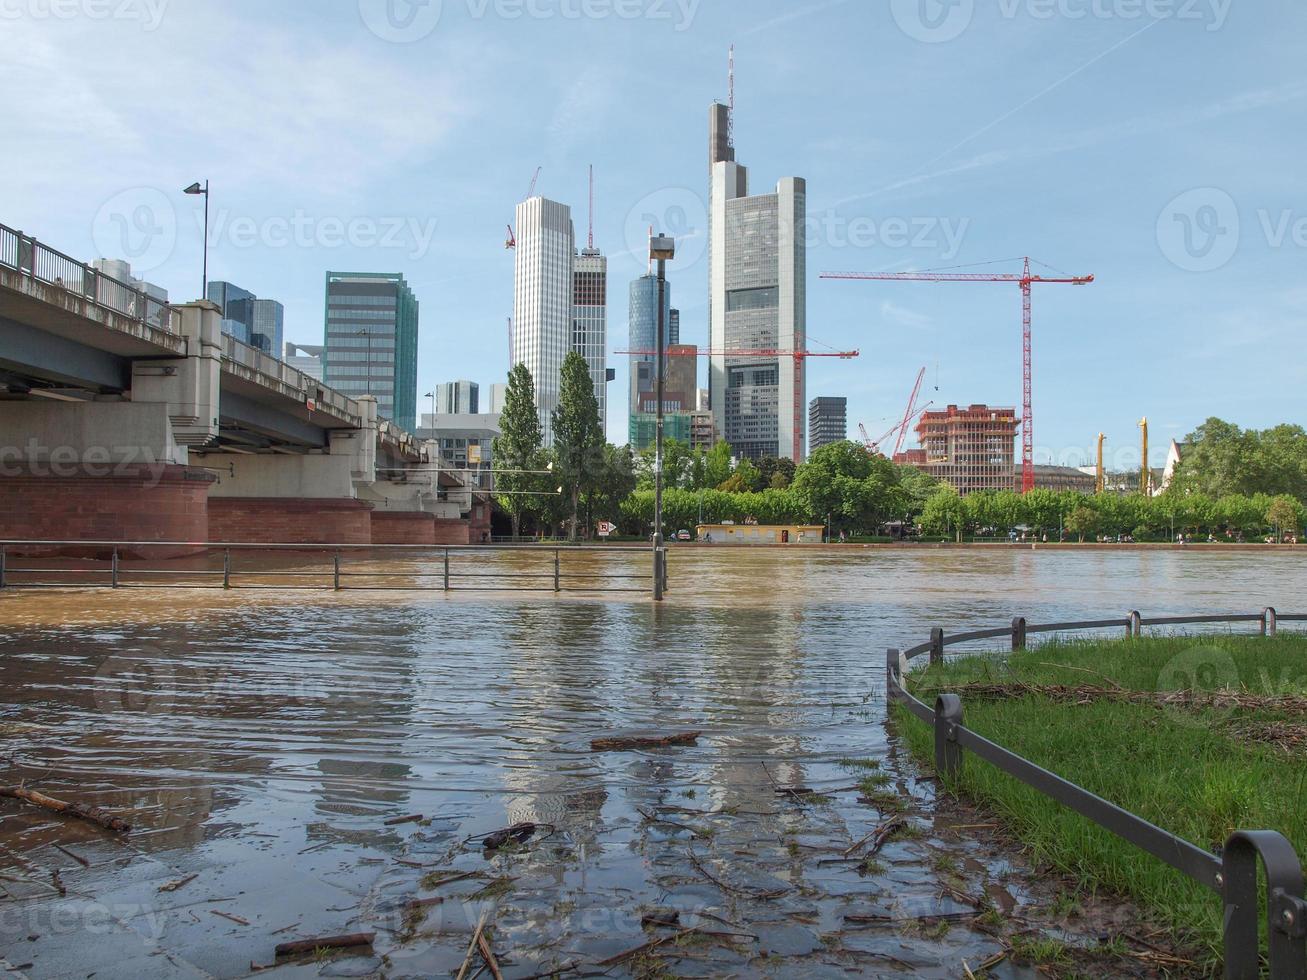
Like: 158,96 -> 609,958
323,272 -> 418,431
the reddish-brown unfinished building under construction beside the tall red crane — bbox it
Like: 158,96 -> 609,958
894,405 -> 1021,497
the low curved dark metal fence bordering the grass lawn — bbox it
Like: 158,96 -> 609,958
886,609 -> 1307,980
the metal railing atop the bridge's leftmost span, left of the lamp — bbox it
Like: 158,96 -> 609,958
0,225 -> 180,335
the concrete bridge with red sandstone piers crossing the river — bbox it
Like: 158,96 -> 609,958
0,225 -> 490,554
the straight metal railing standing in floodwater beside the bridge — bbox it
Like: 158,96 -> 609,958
0,541 -> 667,593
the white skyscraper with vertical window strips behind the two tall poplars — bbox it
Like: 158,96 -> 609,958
512,197 -> 576,446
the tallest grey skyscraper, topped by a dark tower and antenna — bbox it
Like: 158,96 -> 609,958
708,105 -> 808,463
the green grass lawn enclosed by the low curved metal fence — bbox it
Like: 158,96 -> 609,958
894,634 -> 1307,967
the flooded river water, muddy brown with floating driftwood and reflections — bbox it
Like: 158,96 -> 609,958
0,549 -> 1307,977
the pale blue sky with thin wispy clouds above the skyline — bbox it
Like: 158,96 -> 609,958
0,0 -> 1307,469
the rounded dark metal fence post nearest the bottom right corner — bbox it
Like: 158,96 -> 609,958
1221,830 -> 1307,980
